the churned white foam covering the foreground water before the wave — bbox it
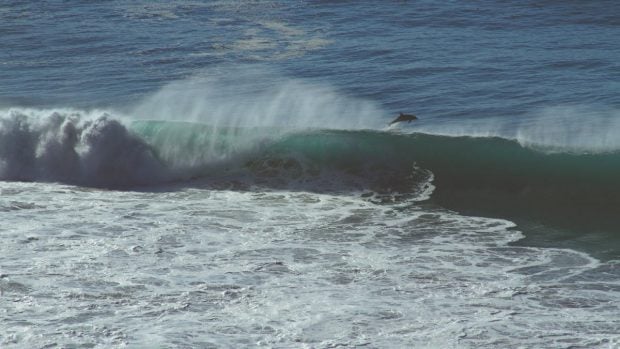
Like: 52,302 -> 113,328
0,182 -> 620,348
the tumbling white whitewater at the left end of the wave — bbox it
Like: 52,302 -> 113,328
0,108 -> 166,187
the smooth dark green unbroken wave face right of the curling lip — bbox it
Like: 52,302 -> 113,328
400,135 -> 620,231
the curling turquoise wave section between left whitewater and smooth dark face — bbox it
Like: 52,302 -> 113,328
129,121 -> 432,201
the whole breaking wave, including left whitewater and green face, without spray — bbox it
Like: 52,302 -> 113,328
0,109 -> 620,237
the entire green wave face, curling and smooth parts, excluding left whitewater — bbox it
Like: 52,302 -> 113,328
130,117 -> 620,239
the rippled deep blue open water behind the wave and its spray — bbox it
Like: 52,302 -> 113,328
0,1 -> 620,118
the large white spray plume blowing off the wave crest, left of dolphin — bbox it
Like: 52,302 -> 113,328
129,65 -> 384,130
